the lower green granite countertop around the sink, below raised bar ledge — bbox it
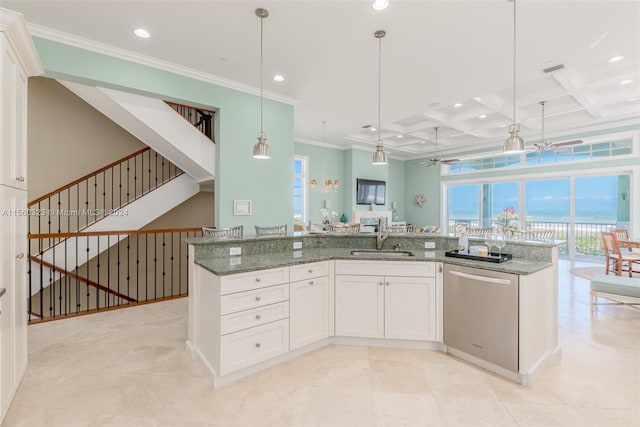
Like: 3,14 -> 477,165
195,248 -> 552,276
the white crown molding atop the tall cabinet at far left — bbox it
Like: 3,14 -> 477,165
0,8 -> 44,76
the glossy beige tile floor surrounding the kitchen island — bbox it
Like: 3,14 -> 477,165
3,261 -> 640,427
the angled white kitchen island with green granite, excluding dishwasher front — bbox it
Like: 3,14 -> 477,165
186,234 -> 560,387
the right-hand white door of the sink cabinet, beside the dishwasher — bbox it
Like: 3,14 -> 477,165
384,276 -> 436,341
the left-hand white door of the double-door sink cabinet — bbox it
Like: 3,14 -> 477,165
336,275 -> 385,338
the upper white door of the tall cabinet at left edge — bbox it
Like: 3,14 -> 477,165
0,33 -> 27,190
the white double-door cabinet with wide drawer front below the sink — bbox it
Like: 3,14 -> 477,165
335,261 -> 437,340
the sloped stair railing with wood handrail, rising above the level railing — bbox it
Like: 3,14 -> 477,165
27,147 -> 184,241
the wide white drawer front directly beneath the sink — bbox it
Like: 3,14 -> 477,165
336,260 -> 436,277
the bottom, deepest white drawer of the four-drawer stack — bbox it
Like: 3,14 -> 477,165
220,319 -> 289,375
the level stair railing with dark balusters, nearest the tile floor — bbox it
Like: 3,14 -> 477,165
27,227 -> 202,323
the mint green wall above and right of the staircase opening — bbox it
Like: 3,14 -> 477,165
34,37 -> 294,234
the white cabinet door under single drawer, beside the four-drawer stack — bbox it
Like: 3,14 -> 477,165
289,276 -> 329,350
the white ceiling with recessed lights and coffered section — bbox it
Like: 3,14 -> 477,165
2,0 -> 640,159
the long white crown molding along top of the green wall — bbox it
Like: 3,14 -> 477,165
27,23 -> 298,105
